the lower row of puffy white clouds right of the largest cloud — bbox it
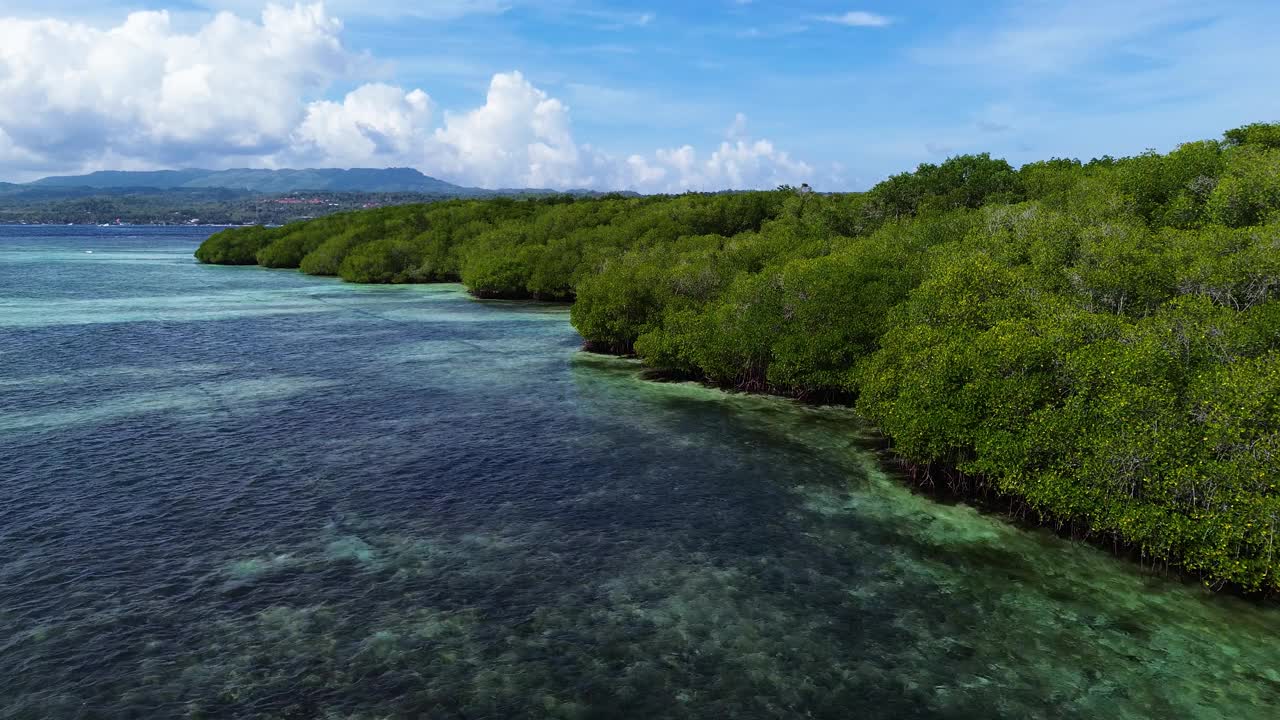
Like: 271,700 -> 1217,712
289,72 -> 813,192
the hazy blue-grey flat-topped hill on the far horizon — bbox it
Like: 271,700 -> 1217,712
30,168 -> 468,196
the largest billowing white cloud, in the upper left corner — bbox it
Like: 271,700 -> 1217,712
0,5 -> 357,164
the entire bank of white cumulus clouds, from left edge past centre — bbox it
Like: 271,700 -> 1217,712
0,5 -> 813,192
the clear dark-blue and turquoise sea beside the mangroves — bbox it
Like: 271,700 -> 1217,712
0,227 -> 1280,719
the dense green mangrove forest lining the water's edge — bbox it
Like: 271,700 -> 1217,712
197,124 -> 1280,593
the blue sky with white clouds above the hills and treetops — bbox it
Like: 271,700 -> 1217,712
0,0 -> 1280,192
